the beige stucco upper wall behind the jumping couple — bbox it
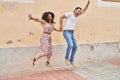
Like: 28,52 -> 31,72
0,0 -> 120,47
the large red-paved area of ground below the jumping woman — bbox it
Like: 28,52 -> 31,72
0,68 -> 85,80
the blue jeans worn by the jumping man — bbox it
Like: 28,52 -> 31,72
63,30 -> 77,62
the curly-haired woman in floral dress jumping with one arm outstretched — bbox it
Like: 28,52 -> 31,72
28,11 -> 59,67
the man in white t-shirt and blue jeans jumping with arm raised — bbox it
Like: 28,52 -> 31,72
60,0 -> 90,66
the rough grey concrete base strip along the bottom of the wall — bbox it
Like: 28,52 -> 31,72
0,42 -> 120,75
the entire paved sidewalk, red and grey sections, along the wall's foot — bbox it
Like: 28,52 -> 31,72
0,58 -> 120,80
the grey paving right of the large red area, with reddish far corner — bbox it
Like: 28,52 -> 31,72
73,58 -> 120,80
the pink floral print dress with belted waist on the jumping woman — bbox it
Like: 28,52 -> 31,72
40,25 -> 53,56
